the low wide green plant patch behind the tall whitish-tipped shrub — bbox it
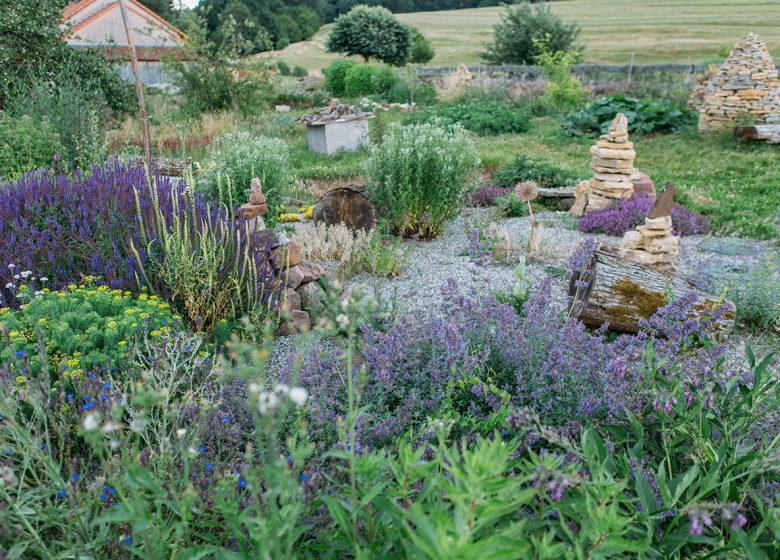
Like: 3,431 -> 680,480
407,101 -> 531,136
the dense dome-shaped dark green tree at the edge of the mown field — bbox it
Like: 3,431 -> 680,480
325,6 -> 412,66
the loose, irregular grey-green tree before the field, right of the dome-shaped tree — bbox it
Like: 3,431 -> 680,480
482,2 -> 583,64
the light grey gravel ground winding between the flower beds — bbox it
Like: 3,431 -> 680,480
266,208 -> 777,376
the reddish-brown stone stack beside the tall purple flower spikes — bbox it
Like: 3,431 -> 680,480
238,177 -> 325,334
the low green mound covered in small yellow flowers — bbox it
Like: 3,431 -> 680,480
0,284 -> 175,379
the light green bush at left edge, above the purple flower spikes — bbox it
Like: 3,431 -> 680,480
0,112 -> 62,179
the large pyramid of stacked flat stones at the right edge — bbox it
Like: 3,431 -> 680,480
699,33 -> 780,131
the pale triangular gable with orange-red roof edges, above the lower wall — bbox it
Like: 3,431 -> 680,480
62,0 -> 185,54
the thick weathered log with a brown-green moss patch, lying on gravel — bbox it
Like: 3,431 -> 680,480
569,244 -> 736,335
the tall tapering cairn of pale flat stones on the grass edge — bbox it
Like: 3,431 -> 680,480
570,113 -> 638,216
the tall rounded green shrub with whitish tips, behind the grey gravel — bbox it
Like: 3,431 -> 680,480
364,123 -> 479,237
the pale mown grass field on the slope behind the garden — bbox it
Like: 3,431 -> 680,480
263,0 -> 780,70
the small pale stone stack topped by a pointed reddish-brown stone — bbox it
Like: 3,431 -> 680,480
620,181 -> 680,273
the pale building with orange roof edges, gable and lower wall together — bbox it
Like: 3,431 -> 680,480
62,0 -> 185,85
